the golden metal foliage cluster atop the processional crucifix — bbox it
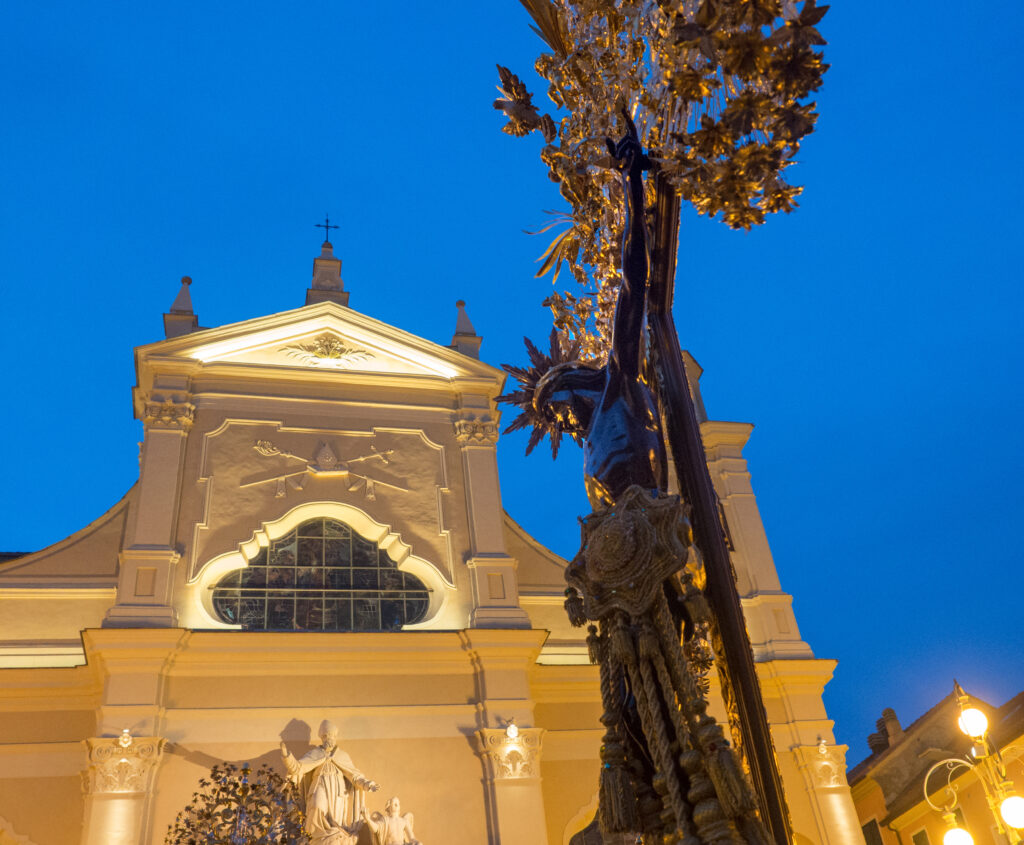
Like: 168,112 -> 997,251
495,0 -> 828,362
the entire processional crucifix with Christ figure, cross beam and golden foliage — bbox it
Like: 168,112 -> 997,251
494,0 -> 828,845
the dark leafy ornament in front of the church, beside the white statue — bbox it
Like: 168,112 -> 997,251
164,763 -> 308,845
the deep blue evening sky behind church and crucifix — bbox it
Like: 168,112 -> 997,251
0,0 -> 1024,764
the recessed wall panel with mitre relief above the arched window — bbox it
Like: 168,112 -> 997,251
181,420 -> 459,582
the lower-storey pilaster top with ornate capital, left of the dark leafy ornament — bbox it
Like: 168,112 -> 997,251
82,729 -> 165,845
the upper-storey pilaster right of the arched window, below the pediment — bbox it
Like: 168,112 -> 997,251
455,396 -> 529,628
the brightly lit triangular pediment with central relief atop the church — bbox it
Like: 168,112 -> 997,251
136,302 -> 503,380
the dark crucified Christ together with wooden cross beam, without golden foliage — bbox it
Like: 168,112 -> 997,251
499,112 -> 792,845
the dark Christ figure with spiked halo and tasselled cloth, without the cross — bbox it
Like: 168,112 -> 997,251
499,113 -> 768,845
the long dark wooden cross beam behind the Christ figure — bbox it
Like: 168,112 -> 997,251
648,175 -> 793,845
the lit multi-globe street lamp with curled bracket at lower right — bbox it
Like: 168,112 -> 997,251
924,681 -> 1024,845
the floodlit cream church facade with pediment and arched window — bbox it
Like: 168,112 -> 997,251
0,243 -> 862,845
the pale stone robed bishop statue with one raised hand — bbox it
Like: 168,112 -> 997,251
281,720 -> 380,845
